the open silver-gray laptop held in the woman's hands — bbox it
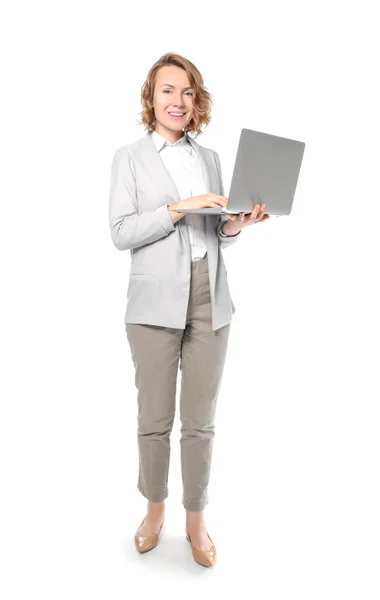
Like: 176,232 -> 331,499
170,129 -> 305,216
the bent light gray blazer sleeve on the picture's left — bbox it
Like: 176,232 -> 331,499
109,147 -> 175,250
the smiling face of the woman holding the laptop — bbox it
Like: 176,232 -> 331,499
153,65 -> 194,143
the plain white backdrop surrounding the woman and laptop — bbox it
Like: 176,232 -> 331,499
0,0 -> 380,600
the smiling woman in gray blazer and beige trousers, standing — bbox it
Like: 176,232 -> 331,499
109,54 -> 268,566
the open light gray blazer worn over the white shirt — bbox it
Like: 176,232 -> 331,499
109,132 -> 240,331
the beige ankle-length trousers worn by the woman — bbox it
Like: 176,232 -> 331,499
125,255 -> 230,511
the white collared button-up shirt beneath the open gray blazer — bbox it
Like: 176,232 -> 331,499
152,131 -> 208,261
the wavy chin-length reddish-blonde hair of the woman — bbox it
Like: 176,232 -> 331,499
139,52 -> 213,137
